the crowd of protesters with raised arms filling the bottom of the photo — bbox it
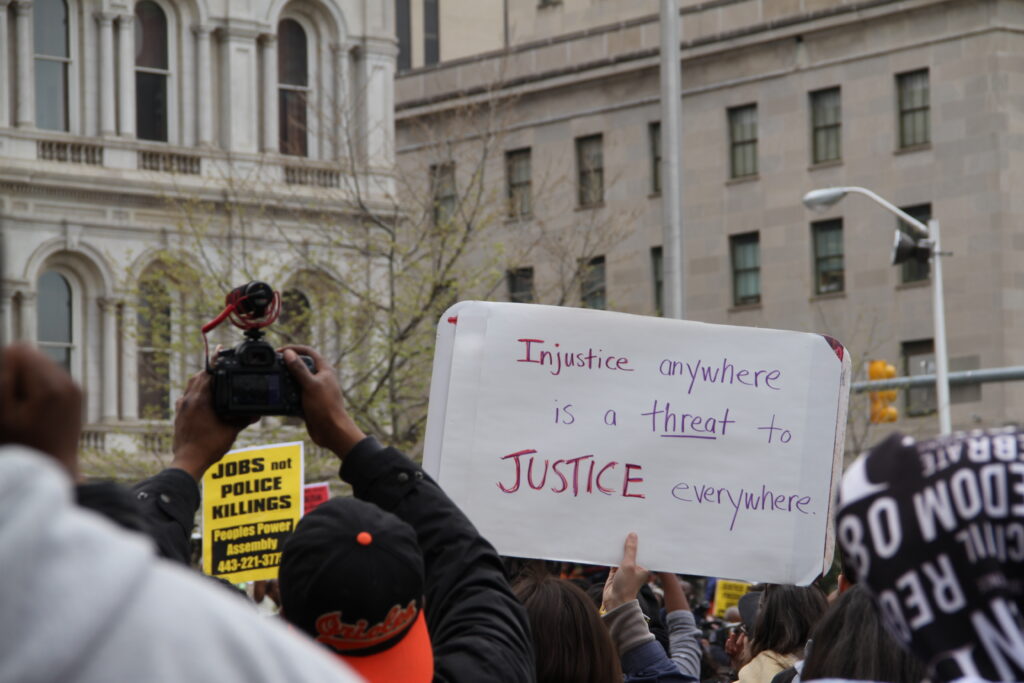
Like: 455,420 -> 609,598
0,346 -> 1024,683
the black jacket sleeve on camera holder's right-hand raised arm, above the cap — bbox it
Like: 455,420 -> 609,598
341,437 -> 537,683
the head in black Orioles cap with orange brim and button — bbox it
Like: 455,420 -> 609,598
279,498 -> 433,683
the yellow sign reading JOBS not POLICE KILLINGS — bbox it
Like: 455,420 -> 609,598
203,441 -> 302,583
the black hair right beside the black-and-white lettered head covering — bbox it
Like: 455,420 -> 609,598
801,586 -> 927,683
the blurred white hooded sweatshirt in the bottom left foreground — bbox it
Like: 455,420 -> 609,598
0,446 -> 359,683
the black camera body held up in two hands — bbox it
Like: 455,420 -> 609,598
212,339 -> 316,417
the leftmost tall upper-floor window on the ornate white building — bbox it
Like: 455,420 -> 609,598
34,0 -> 71,130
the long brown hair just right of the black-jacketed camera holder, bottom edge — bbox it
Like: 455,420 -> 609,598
512,573 -> 623,683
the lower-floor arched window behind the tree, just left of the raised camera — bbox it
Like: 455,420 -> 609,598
136,272 -> 171,420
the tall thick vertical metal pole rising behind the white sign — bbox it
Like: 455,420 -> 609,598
662,0 -> 686,319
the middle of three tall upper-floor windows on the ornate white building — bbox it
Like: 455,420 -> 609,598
135,0 -> 171,141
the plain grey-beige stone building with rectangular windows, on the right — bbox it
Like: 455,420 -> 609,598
395,0 -> 1024,447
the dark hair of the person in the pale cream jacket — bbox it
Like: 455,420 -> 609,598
751,585 -> 828,657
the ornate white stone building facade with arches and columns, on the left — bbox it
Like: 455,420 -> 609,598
0,0 -> 396,471
